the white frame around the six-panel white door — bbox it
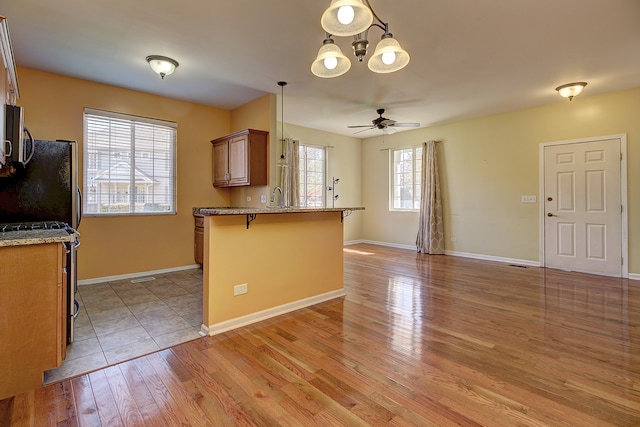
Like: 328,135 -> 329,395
538,134 -> 629,278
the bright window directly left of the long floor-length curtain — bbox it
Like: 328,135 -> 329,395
390,147 -> 422,211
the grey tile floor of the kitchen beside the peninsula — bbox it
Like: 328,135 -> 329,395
44,269 -> 202,384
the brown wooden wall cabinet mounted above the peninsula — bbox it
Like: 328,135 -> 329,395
211,129 -> 269,187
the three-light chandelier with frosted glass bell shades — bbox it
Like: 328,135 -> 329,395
311,0 -> 410,78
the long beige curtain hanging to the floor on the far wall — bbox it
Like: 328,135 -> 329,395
416,141 -> 444,254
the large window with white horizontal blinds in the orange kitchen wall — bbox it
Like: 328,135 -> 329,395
83,108 -> 177,216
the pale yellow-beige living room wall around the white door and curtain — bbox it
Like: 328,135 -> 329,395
362,88 -> 640,273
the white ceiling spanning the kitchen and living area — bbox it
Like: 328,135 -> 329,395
0,0 -> 640,138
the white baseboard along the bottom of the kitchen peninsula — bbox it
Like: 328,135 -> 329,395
200,288 -> 347,336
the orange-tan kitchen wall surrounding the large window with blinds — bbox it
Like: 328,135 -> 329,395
18,68 -> 231,280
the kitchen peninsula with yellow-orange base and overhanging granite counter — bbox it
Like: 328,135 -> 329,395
193,207 -> 364,335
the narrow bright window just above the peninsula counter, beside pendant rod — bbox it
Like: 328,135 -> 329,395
298,144 -> 327,208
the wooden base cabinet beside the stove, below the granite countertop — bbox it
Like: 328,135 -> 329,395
0,243 -> 67,400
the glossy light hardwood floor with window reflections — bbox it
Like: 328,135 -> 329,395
0,244 -> 640,426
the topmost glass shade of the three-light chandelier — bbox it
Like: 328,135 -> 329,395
320,0 -> 373,36
